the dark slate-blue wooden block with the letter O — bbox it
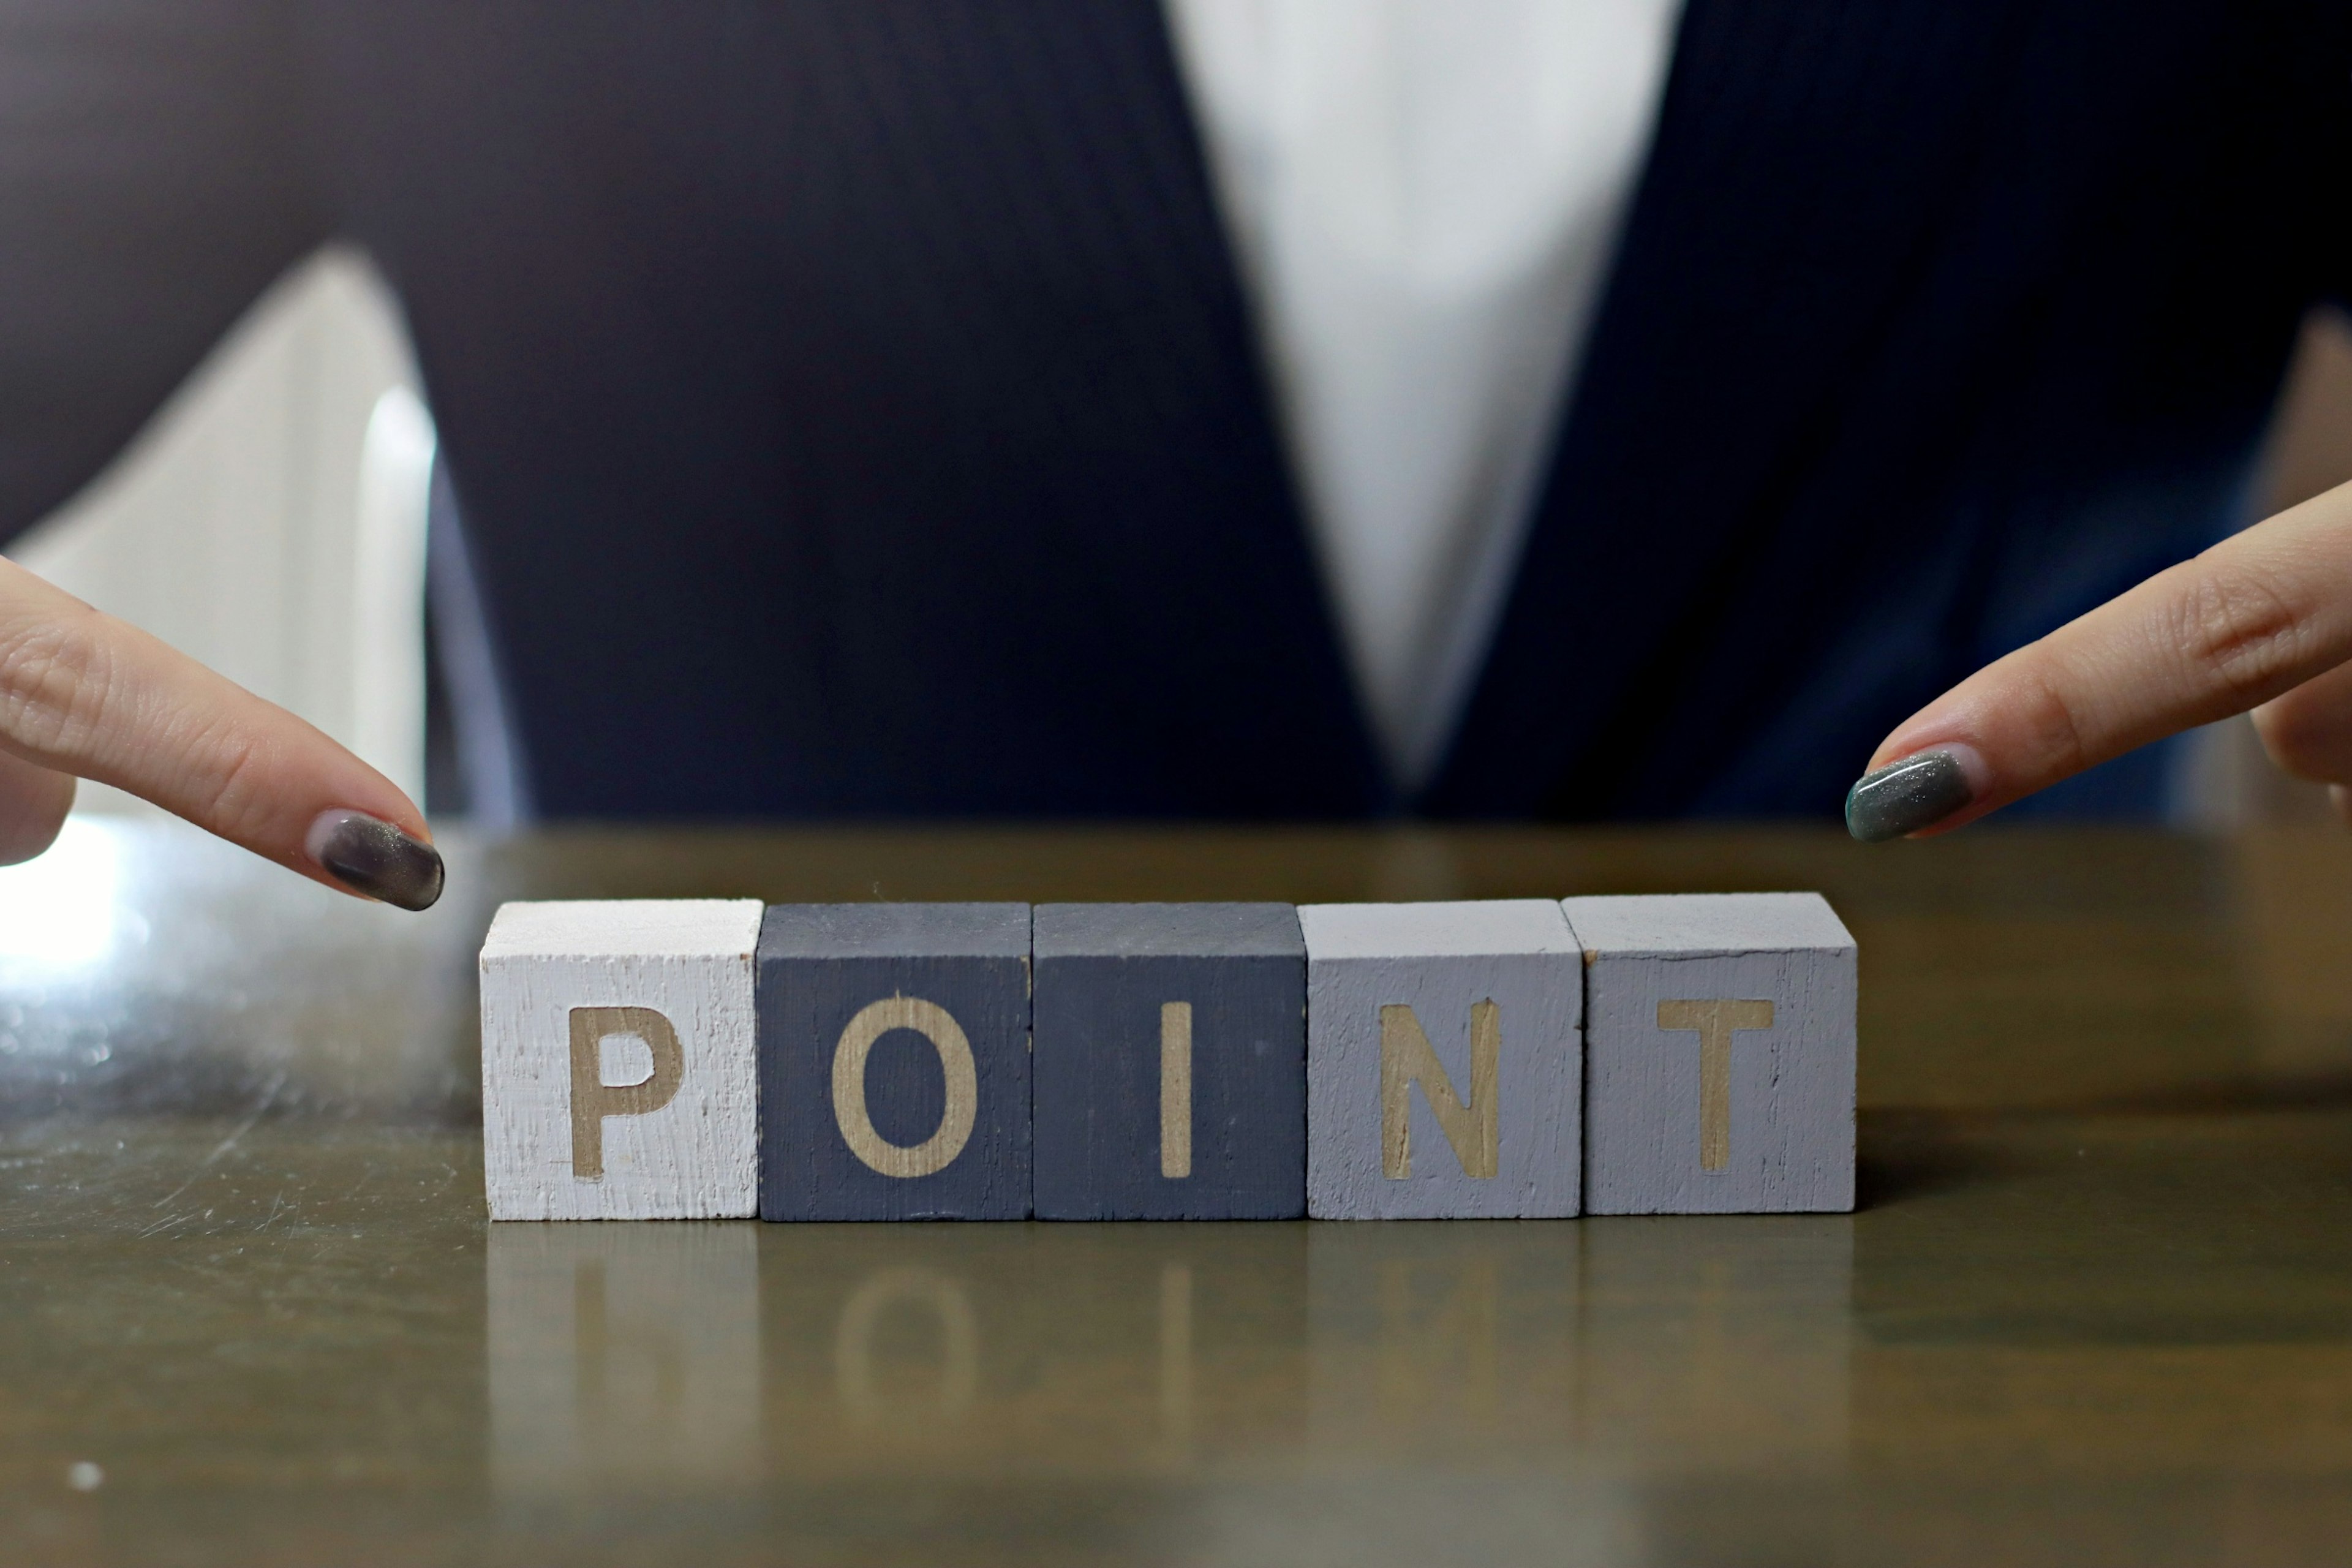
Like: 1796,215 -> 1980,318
760,903 -> 1030,1220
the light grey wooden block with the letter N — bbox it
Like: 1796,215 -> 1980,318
1298,898 -> 1583,1220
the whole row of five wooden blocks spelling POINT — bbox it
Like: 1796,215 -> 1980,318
482,893 -> 1856,1220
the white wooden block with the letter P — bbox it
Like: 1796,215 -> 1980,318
482,898 -> 760,1220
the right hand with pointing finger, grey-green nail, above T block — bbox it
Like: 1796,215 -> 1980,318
1846,484 -> 2352,842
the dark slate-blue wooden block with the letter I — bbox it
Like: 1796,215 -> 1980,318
1035,903 -> 1308,1220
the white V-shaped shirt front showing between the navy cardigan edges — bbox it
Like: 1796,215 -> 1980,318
1167,0 -> 1682,788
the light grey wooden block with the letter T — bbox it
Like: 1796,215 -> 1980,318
1562,893 -> 1856,1213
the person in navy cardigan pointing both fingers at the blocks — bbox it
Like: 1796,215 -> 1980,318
0,0 -> 2352,905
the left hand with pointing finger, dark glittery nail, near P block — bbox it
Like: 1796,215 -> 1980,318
0,559 -> 442,910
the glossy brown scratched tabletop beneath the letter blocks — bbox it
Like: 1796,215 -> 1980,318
0,818 -> 2352,1568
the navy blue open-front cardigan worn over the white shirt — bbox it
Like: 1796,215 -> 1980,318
0,0 -> 2352,818
